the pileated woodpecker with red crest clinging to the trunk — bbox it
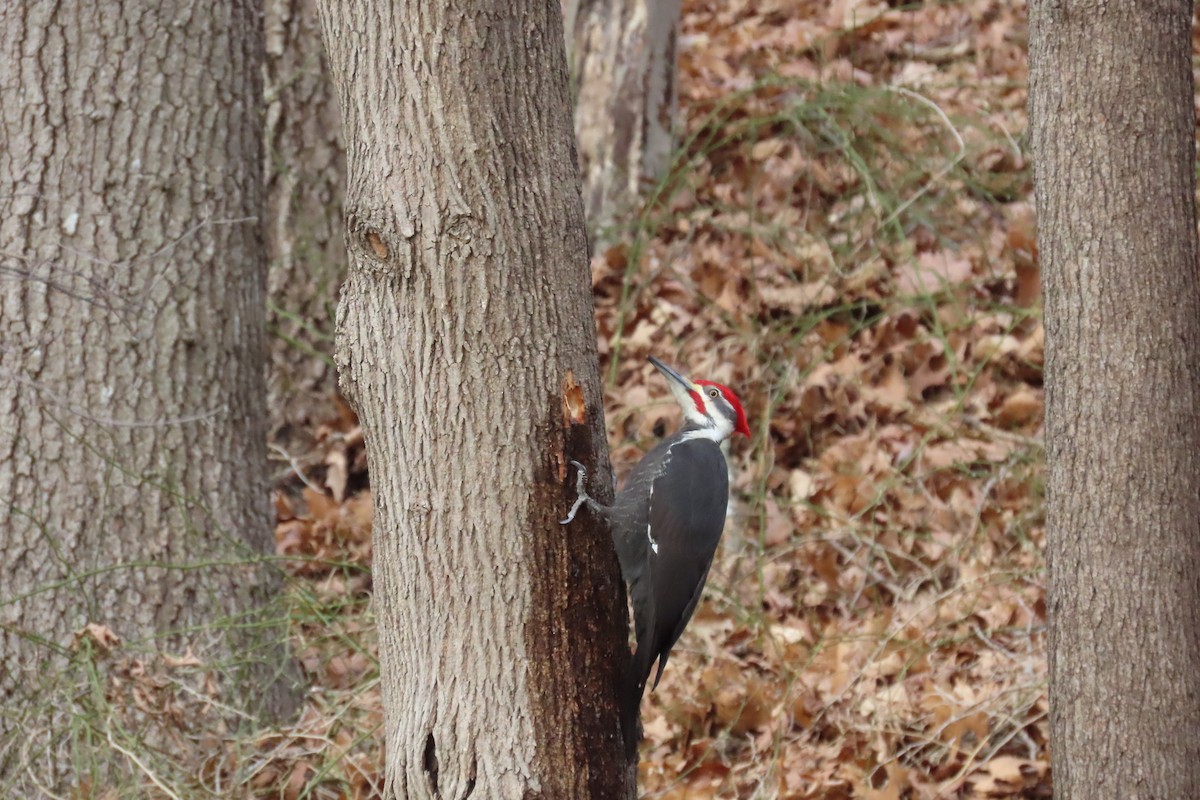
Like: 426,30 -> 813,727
563,356 -> 750,754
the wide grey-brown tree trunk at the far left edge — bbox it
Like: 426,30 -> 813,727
0,0 -> 298,796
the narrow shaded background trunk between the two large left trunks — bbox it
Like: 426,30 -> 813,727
264,0 -> 346,441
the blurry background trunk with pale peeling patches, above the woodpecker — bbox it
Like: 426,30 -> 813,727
564,0 -> 679,247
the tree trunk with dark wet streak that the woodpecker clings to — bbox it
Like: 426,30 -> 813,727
320,0 -> 634,800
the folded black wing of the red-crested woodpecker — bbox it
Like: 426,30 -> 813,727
635,439 -> 730,690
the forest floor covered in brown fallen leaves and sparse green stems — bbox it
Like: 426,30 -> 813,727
260,0 -> 1050,800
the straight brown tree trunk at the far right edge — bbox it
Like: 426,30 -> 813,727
1030,0 -> 1200,798
